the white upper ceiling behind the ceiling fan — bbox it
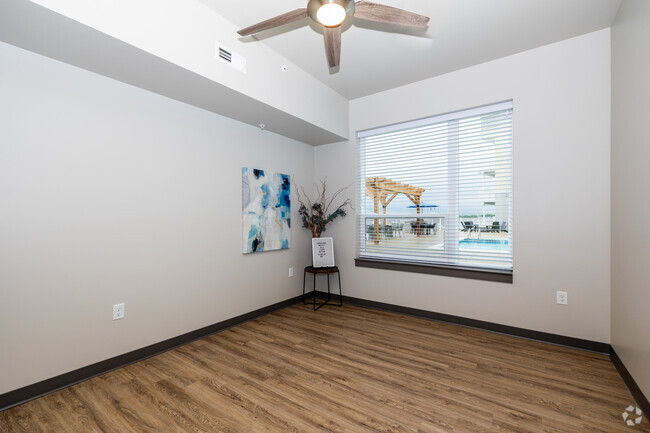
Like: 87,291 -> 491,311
201,0 -> 621,99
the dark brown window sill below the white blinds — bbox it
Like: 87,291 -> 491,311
354,258 -> 512,284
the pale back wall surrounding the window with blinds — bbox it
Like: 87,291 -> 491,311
315,29 -> 611,343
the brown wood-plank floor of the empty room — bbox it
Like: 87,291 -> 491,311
0,305 -> 650,433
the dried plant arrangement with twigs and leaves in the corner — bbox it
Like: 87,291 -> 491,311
293,179 -> 353,238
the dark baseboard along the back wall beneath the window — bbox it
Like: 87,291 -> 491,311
317,291 -> 610,355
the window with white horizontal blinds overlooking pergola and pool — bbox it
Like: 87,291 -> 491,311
357,102 -> 512,275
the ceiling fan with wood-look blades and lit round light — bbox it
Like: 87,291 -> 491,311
237,0 -> 429,68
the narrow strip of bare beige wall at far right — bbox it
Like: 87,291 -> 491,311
612,0 -> 650,397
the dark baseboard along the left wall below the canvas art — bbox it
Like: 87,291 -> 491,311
0,296 -> 302,412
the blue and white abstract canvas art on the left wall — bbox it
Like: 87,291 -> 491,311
242,167 -> 291,254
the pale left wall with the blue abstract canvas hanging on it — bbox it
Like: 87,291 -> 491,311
0,43 -> 313,394
